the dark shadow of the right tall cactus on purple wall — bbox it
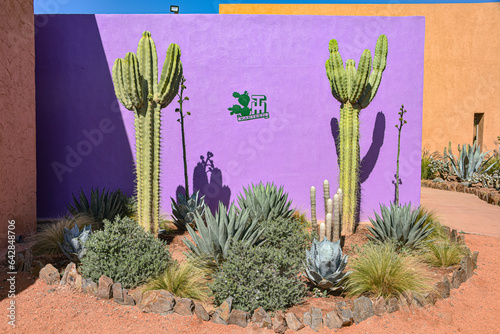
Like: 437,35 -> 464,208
330,111 -> 386,221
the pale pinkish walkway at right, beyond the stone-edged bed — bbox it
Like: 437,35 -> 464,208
420,187 -> 500,237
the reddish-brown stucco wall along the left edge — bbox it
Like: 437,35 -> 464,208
0,0 -> 36,250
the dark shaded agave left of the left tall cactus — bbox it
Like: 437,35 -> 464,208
68,188 -> 127,229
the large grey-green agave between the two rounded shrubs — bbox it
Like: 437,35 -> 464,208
183,202 -> 264,268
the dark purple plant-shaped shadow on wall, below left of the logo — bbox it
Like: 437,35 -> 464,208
176,151 -> 231,213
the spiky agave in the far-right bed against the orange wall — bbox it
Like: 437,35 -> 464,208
444,142 -> 496,181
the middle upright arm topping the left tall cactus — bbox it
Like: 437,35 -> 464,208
137,31 -> 158,99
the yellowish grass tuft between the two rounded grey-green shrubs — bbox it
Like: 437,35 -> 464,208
143,261 -> 209,301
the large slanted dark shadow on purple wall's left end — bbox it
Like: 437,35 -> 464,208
35,15 -> 134,218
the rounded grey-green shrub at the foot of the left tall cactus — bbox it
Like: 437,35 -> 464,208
81,217 -> 171,288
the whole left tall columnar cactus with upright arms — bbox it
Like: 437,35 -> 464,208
113,31 -> 182,235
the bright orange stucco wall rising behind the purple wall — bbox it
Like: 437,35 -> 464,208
219,3 -> 500,153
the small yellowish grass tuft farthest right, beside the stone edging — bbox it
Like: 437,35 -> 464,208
423,241 -> 465,268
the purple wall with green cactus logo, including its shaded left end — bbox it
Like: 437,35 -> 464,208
36,15 -> 425,220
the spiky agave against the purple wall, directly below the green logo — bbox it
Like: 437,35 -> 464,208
238,182 -> 295,221
